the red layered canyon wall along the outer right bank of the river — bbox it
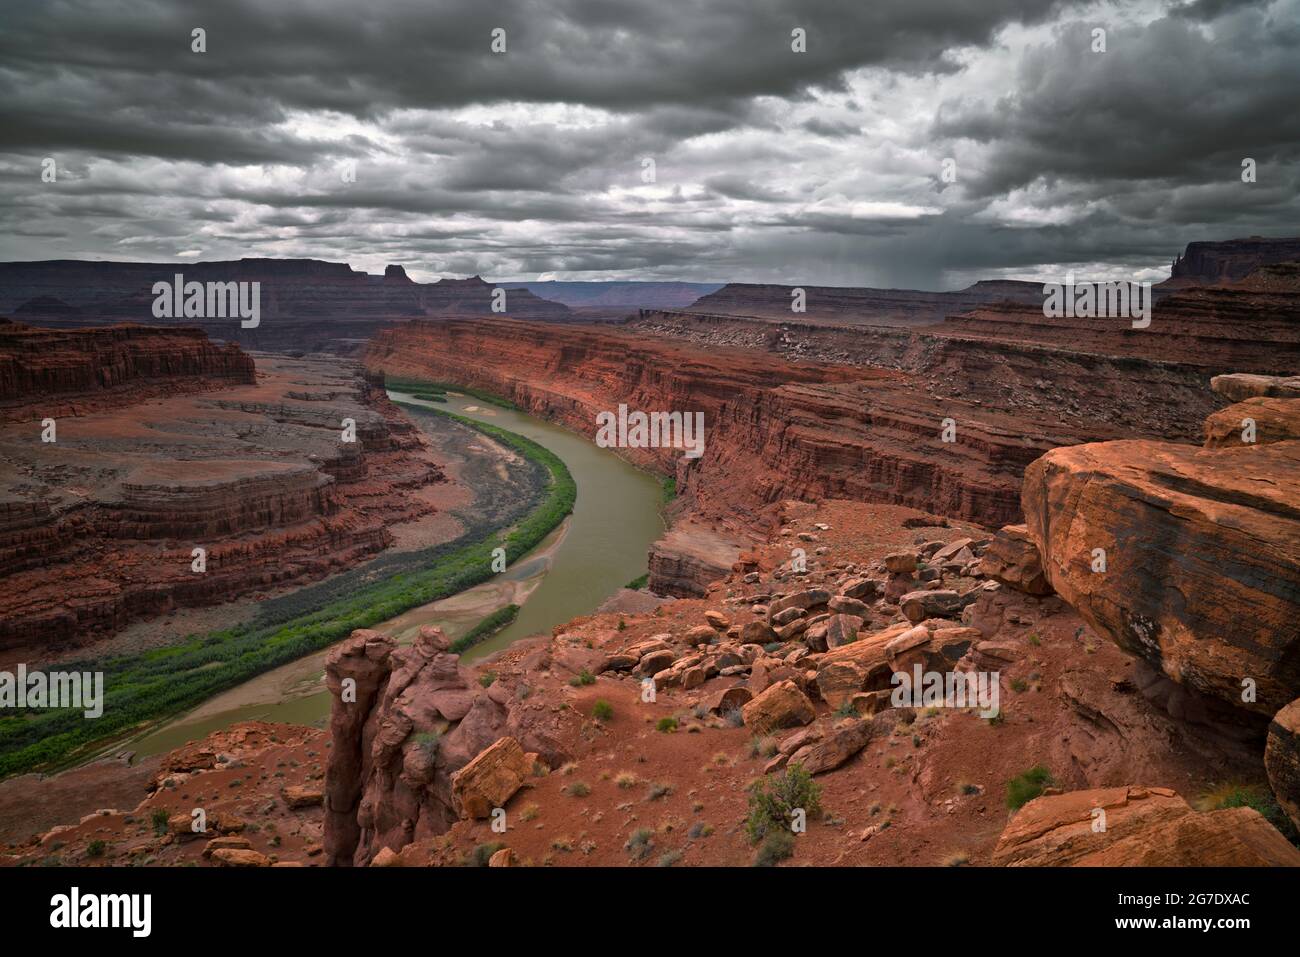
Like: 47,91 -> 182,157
365,320 -> 1123,540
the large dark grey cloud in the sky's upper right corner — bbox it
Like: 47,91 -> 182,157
935,4 -> 1300,202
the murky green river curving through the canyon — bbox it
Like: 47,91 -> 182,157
127,391 -> 664,755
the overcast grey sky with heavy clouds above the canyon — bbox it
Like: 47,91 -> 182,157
0,0 -> 1300,289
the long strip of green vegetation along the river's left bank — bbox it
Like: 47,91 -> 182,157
0,395 -> 577,778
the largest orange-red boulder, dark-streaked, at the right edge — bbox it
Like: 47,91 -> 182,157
1023,416 -> 1300,716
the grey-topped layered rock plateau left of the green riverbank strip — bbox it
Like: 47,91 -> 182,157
0,351 -> 442,661
